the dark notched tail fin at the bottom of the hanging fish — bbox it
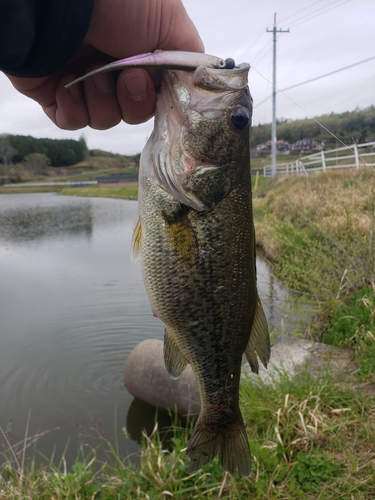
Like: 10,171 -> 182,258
186,418 -> 251,476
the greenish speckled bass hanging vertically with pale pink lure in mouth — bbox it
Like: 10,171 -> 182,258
67,51 -> 270,476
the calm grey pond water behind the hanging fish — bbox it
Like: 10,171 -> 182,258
0,193 -> 304,459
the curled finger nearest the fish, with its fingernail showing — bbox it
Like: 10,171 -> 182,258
117,69 -> 156,125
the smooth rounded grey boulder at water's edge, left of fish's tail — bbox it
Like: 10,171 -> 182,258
124,339 -> 200,416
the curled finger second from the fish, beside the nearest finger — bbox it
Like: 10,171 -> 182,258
84,66 -> 121,130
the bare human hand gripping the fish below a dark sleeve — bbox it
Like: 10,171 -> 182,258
7,0 -> 204,130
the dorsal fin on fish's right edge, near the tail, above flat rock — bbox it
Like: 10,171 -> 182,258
245,297 -> 271,373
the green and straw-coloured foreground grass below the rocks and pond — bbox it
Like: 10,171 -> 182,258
0,369 -> 375,500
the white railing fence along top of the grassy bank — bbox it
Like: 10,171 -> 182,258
263,142 -> 375,177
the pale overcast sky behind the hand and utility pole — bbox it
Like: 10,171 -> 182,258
0,0 -> 375,154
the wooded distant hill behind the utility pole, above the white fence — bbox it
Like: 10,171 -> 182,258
251,106 -> 375,149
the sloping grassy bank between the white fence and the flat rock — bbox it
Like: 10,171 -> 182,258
254,168 -> 375,376
